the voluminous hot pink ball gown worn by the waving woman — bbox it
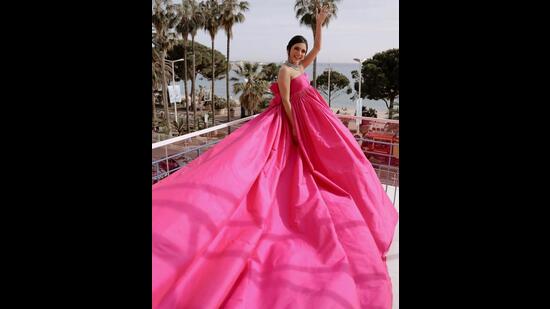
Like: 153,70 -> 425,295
152,73 -> 397,309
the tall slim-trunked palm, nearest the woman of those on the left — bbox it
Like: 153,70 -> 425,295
221,0 -> 249,122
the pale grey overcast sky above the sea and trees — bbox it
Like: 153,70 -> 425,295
166,0 -> 399,63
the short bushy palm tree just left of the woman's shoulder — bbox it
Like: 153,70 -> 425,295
231,62 -> 268,118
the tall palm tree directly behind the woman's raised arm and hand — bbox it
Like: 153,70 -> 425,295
294,0 -> 340,88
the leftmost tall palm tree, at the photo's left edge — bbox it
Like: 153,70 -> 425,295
152,0 -> 179,134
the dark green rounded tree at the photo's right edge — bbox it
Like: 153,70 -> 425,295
352,49 -> 399,119
